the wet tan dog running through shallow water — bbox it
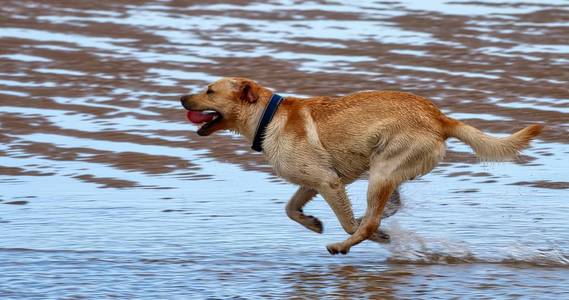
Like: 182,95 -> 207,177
181,78 -> 543,254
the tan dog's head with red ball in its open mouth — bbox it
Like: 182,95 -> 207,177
180,77 -> 270,136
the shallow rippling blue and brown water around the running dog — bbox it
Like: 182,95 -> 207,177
0,0 -> 569,299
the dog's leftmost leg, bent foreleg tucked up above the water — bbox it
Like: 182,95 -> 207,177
286,186 -> 323,233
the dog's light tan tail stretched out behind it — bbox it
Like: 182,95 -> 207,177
443,117 -> 543,161
